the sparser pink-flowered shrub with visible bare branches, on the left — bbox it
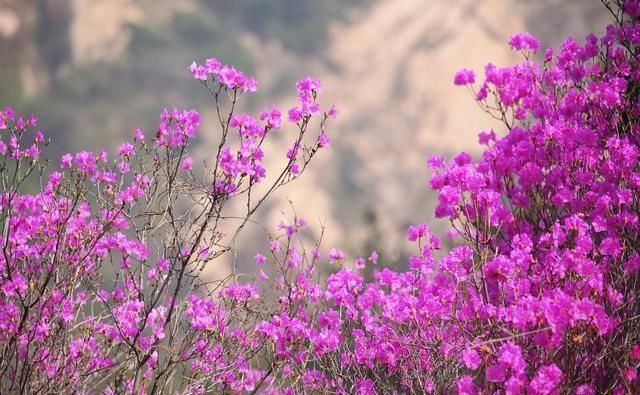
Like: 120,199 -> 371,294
0,59 -> 335,393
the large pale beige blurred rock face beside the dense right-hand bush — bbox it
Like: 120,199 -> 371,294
254,0 -> 608,256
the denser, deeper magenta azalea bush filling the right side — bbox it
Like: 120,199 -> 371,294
179,3 -> 640,394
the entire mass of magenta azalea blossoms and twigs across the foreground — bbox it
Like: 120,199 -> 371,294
0,0 -> 640,395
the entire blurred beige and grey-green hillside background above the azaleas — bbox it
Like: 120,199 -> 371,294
0,0 -> 609,274
